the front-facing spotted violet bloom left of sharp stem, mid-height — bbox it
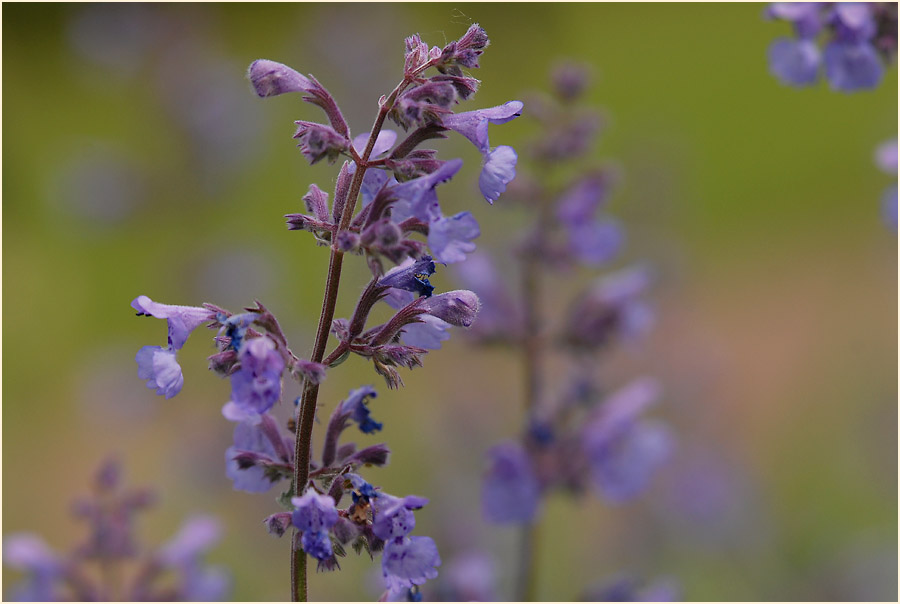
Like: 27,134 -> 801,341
231,336 -> 284,413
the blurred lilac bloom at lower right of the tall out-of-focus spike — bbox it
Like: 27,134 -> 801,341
582,378 -> 672,503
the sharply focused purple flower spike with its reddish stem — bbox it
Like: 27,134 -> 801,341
132,24 -> 523,599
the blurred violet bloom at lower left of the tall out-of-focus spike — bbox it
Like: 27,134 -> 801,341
481,442 -> 540,524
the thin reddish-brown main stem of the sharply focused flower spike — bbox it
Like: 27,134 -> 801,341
291,78 -> 409,602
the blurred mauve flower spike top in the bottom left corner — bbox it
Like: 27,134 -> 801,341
3,461 -> 231,602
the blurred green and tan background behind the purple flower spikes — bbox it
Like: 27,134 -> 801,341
2,4 -> 898,600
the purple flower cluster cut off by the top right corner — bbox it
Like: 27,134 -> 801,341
766,2 -> 897,92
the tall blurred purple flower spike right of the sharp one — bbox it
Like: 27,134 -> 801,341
458,64 -> 672,599
